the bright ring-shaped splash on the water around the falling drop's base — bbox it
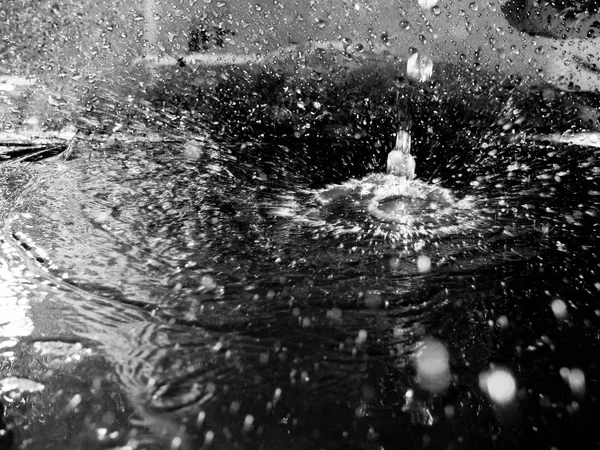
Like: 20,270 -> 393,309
274,174 -> 485,240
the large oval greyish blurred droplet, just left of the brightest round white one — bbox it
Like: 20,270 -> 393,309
415,338 -> 451,393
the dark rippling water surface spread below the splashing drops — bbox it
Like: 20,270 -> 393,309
0,65 -> 600,449
